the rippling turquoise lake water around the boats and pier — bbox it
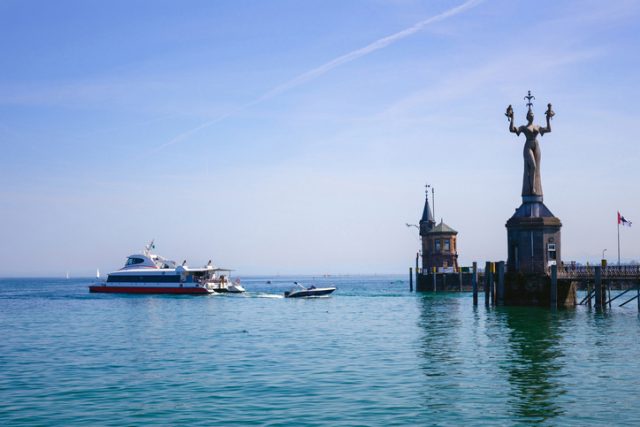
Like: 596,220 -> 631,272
0,276 -> 640,426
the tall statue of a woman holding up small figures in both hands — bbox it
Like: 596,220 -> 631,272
505,91 -> 555,198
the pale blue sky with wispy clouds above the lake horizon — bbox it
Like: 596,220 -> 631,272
0,0 -> 640,276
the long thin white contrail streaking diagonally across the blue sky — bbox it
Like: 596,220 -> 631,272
158,0 -> 483,149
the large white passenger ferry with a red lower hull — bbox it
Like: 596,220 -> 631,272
89,241 -> 245,295
